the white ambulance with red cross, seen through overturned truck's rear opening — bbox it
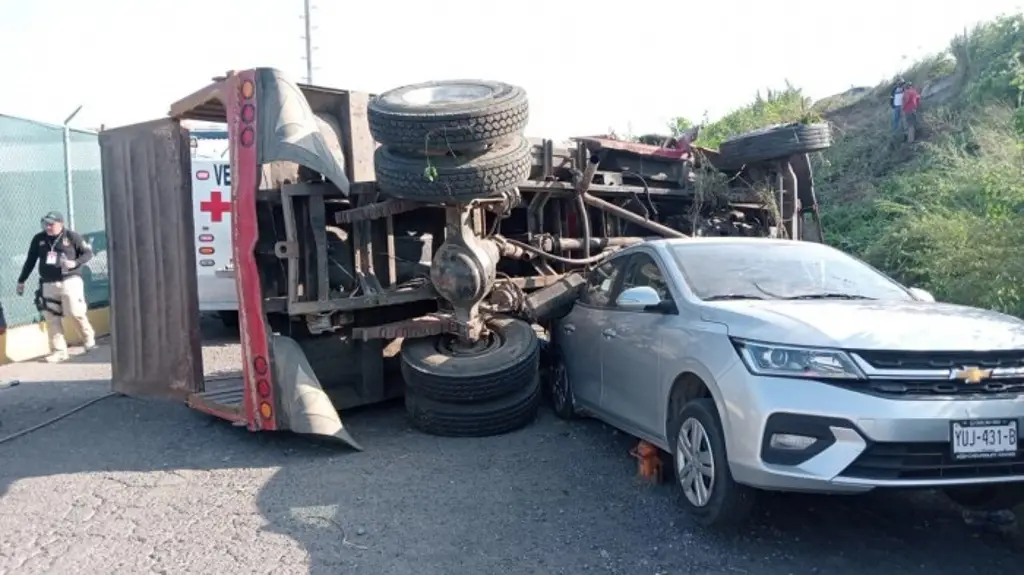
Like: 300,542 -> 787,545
191,156 -> 239,317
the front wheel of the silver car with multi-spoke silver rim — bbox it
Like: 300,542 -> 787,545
669,398 -> 757,529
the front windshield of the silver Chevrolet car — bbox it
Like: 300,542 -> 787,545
672,241 -> 913,300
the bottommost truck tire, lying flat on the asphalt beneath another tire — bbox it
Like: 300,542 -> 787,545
406,373 -> 541,437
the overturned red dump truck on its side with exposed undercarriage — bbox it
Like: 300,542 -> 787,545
99,69 -> 830,448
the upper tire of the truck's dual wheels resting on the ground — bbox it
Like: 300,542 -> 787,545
401,317 -> 541,404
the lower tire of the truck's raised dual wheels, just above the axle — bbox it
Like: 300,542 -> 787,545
374,136 -> 534,203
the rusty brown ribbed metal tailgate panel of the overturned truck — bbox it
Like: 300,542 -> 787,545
99,119 -> 203,399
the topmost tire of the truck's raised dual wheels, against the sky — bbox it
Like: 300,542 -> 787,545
368,80 -> 529,153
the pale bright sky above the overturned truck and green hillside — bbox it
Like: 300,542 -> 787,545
0,0 -> 1024,138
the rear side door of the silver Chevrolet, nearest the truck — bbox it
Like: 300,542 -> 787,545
552,258 -> 627,411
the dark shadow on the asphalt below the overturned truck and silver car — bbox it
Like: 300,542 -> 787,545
0,382 -> 1020,575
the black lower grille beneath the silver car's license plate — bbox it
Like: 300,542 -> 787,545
840,442 -> 1024,480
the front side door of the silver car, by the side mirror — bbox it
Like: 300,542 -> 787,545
600,252 -> 678,437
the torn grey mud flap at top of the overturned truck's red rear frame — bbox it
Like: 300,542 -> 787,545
252,68 -> 349,195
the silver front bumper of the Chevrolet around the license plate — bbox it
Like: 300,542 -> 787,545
719,362 -> 1024,493
